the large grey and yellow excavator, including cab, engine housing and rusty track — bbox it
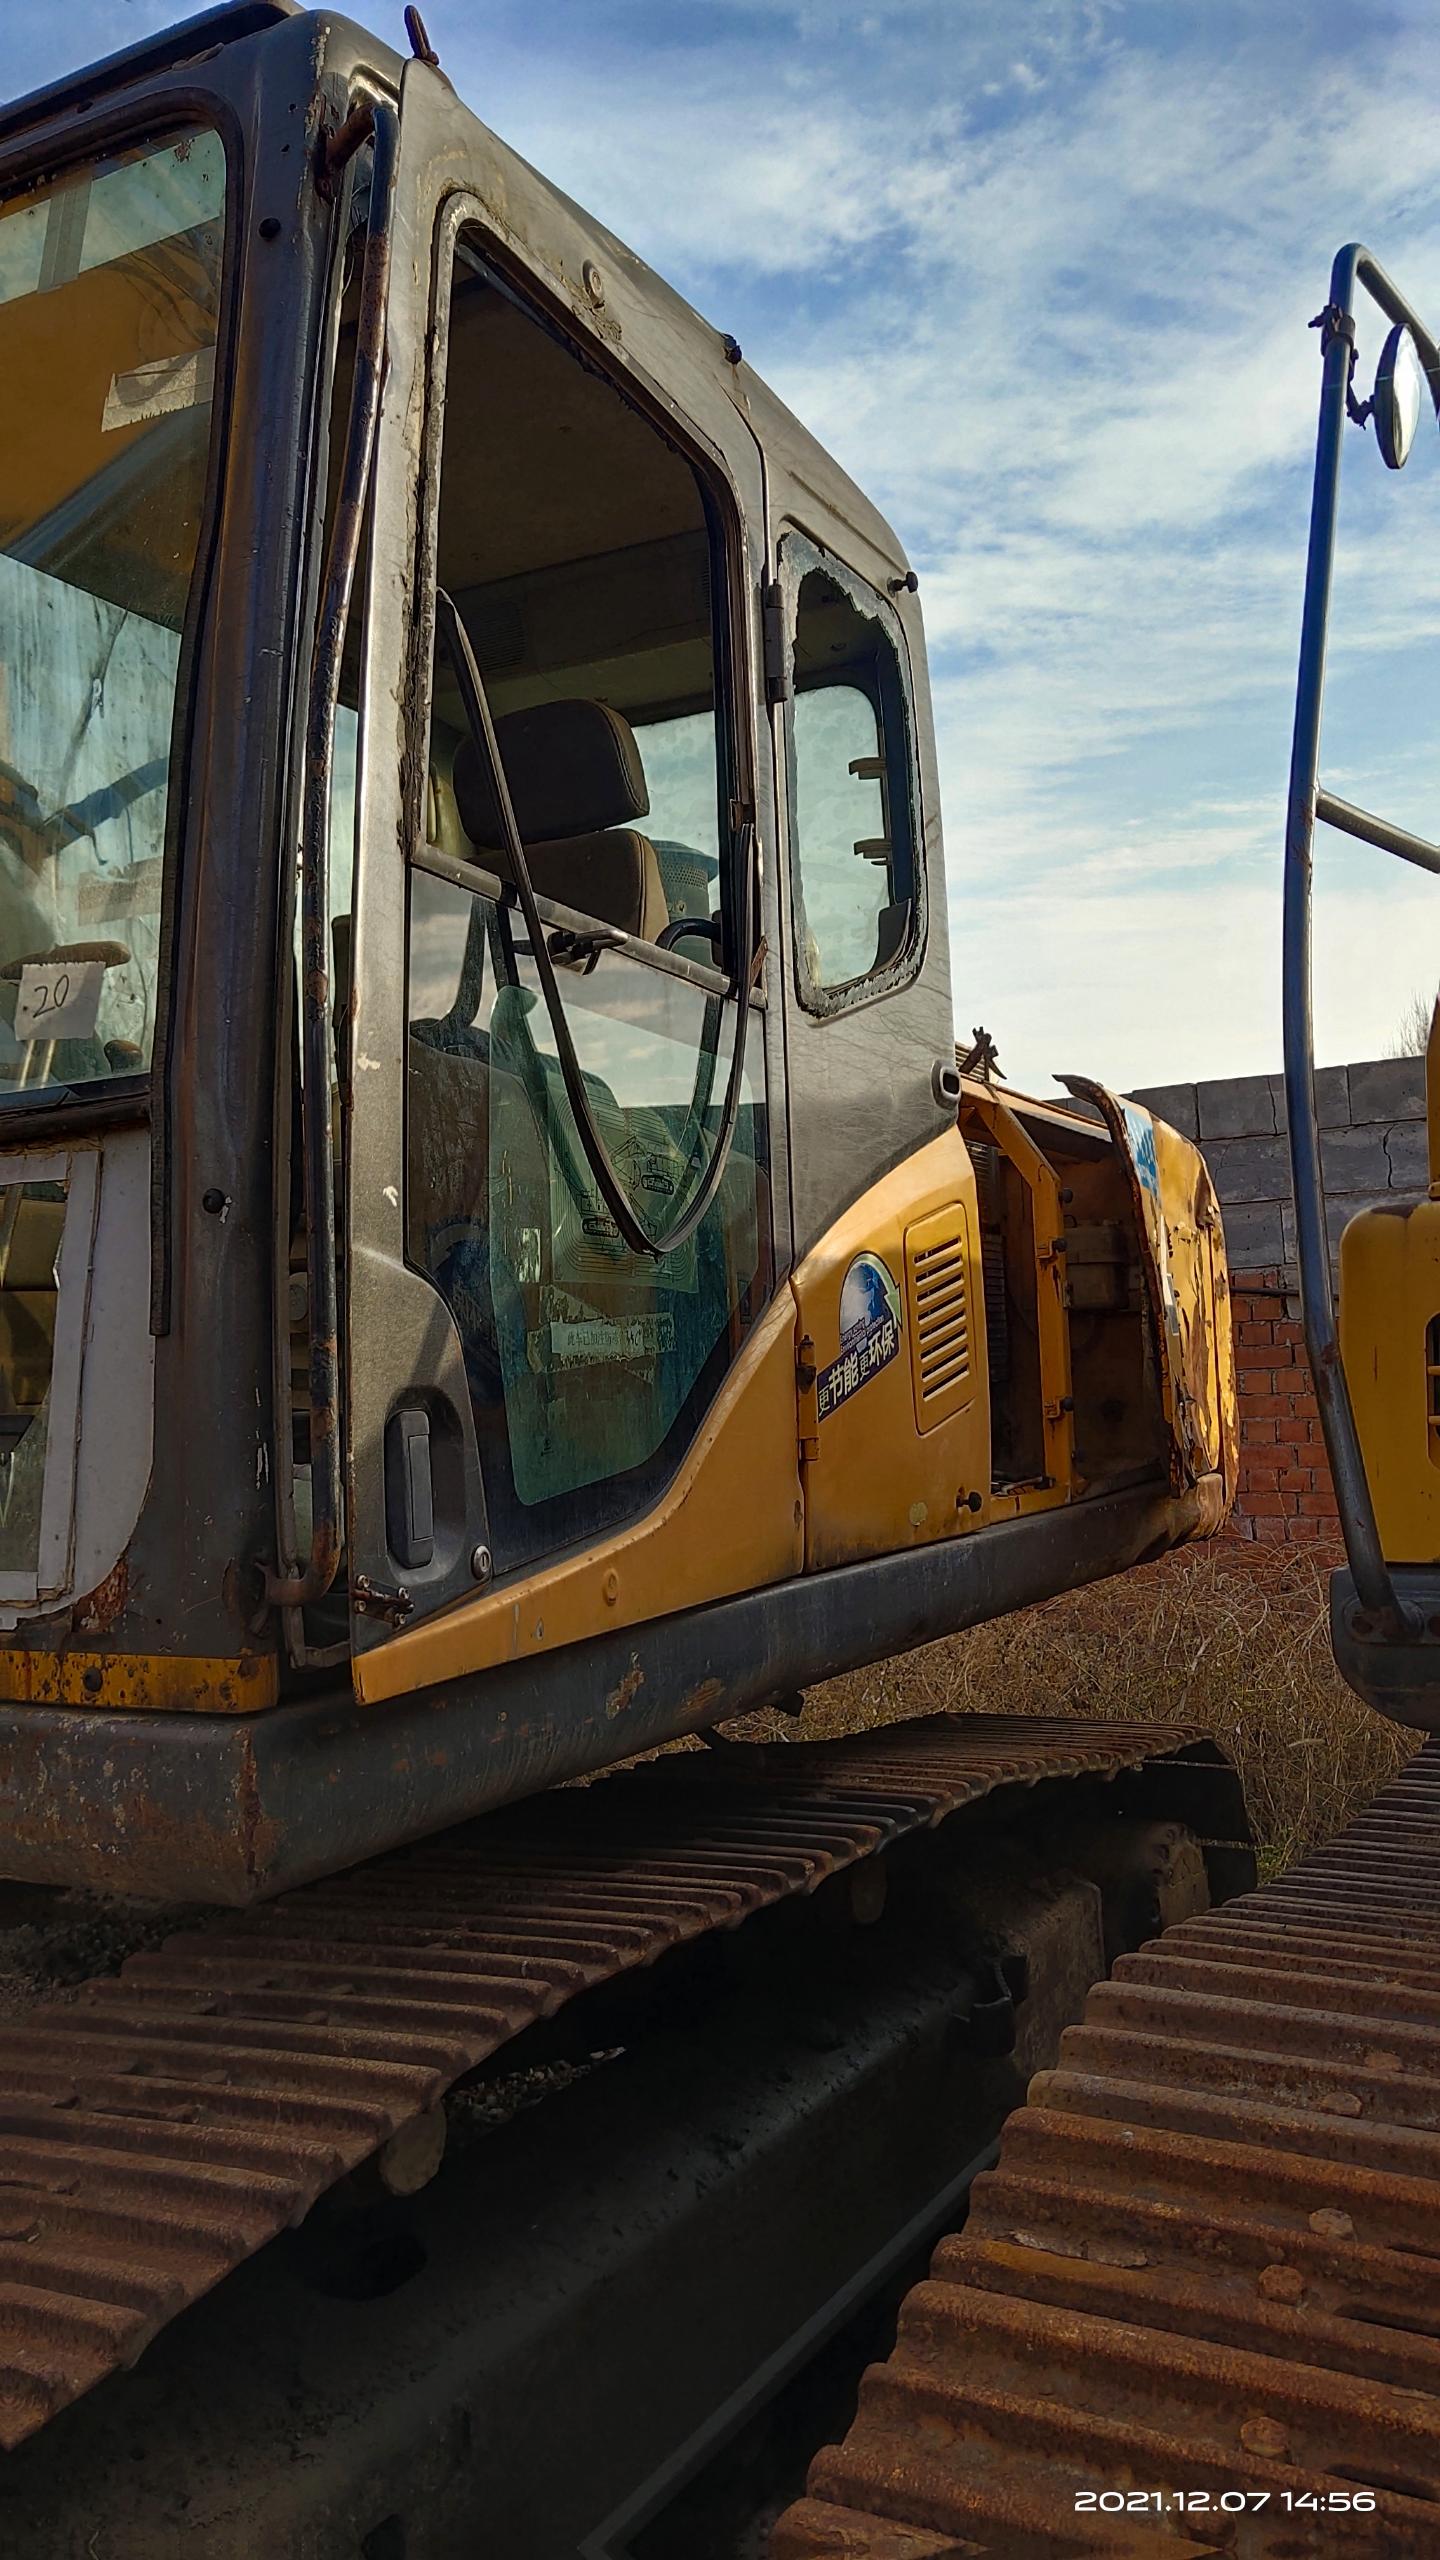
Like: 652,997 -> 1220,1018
0,0 -> 1412,2560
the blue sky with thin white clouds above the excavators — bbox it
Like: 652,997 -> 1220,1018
0,0 -> 1440,1085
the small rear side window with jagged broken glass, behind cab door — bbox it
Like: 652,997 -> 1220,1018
784,538 -> 925,1011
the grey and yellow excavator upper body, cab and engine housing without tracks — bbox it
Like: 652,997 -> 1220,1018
0,0 -> 1232,1902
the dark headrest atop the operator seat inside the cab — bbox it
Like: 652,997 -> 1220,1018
454,701 -> 651,847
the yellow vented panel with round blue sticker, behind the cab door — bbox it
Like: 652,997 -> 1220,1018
794,1129 -> 989,1572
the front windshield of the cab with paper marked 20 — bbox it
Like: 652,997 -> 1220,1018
0,131 -> 225,1101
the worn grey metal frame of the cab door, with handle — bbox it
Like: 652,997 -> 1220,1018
343,61 -> 789,1649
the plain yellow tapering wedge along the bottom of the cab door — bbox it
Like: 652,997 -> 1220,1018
354,1288 -> 805,1702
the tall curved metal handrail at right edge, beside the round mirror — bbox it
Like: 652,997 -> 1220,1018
1281,241 -> 1440,1636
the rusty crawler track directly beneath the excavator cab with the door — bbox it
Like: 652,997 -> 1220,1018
0,1718 -> 1230,2447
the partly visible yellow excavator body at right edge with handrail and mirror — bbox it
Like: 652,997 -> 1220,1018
1284,243 -> 1440,1733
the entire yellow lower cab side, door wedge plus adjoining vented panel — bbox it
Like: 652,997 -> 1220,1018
354,1129 -> 989,1702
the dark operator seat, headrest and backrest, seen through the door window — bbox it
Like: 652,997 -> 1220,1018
454,701 -> 669,942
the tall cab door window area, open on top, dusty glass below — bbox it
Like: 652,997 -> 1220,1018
405,233 -> 771,1574
